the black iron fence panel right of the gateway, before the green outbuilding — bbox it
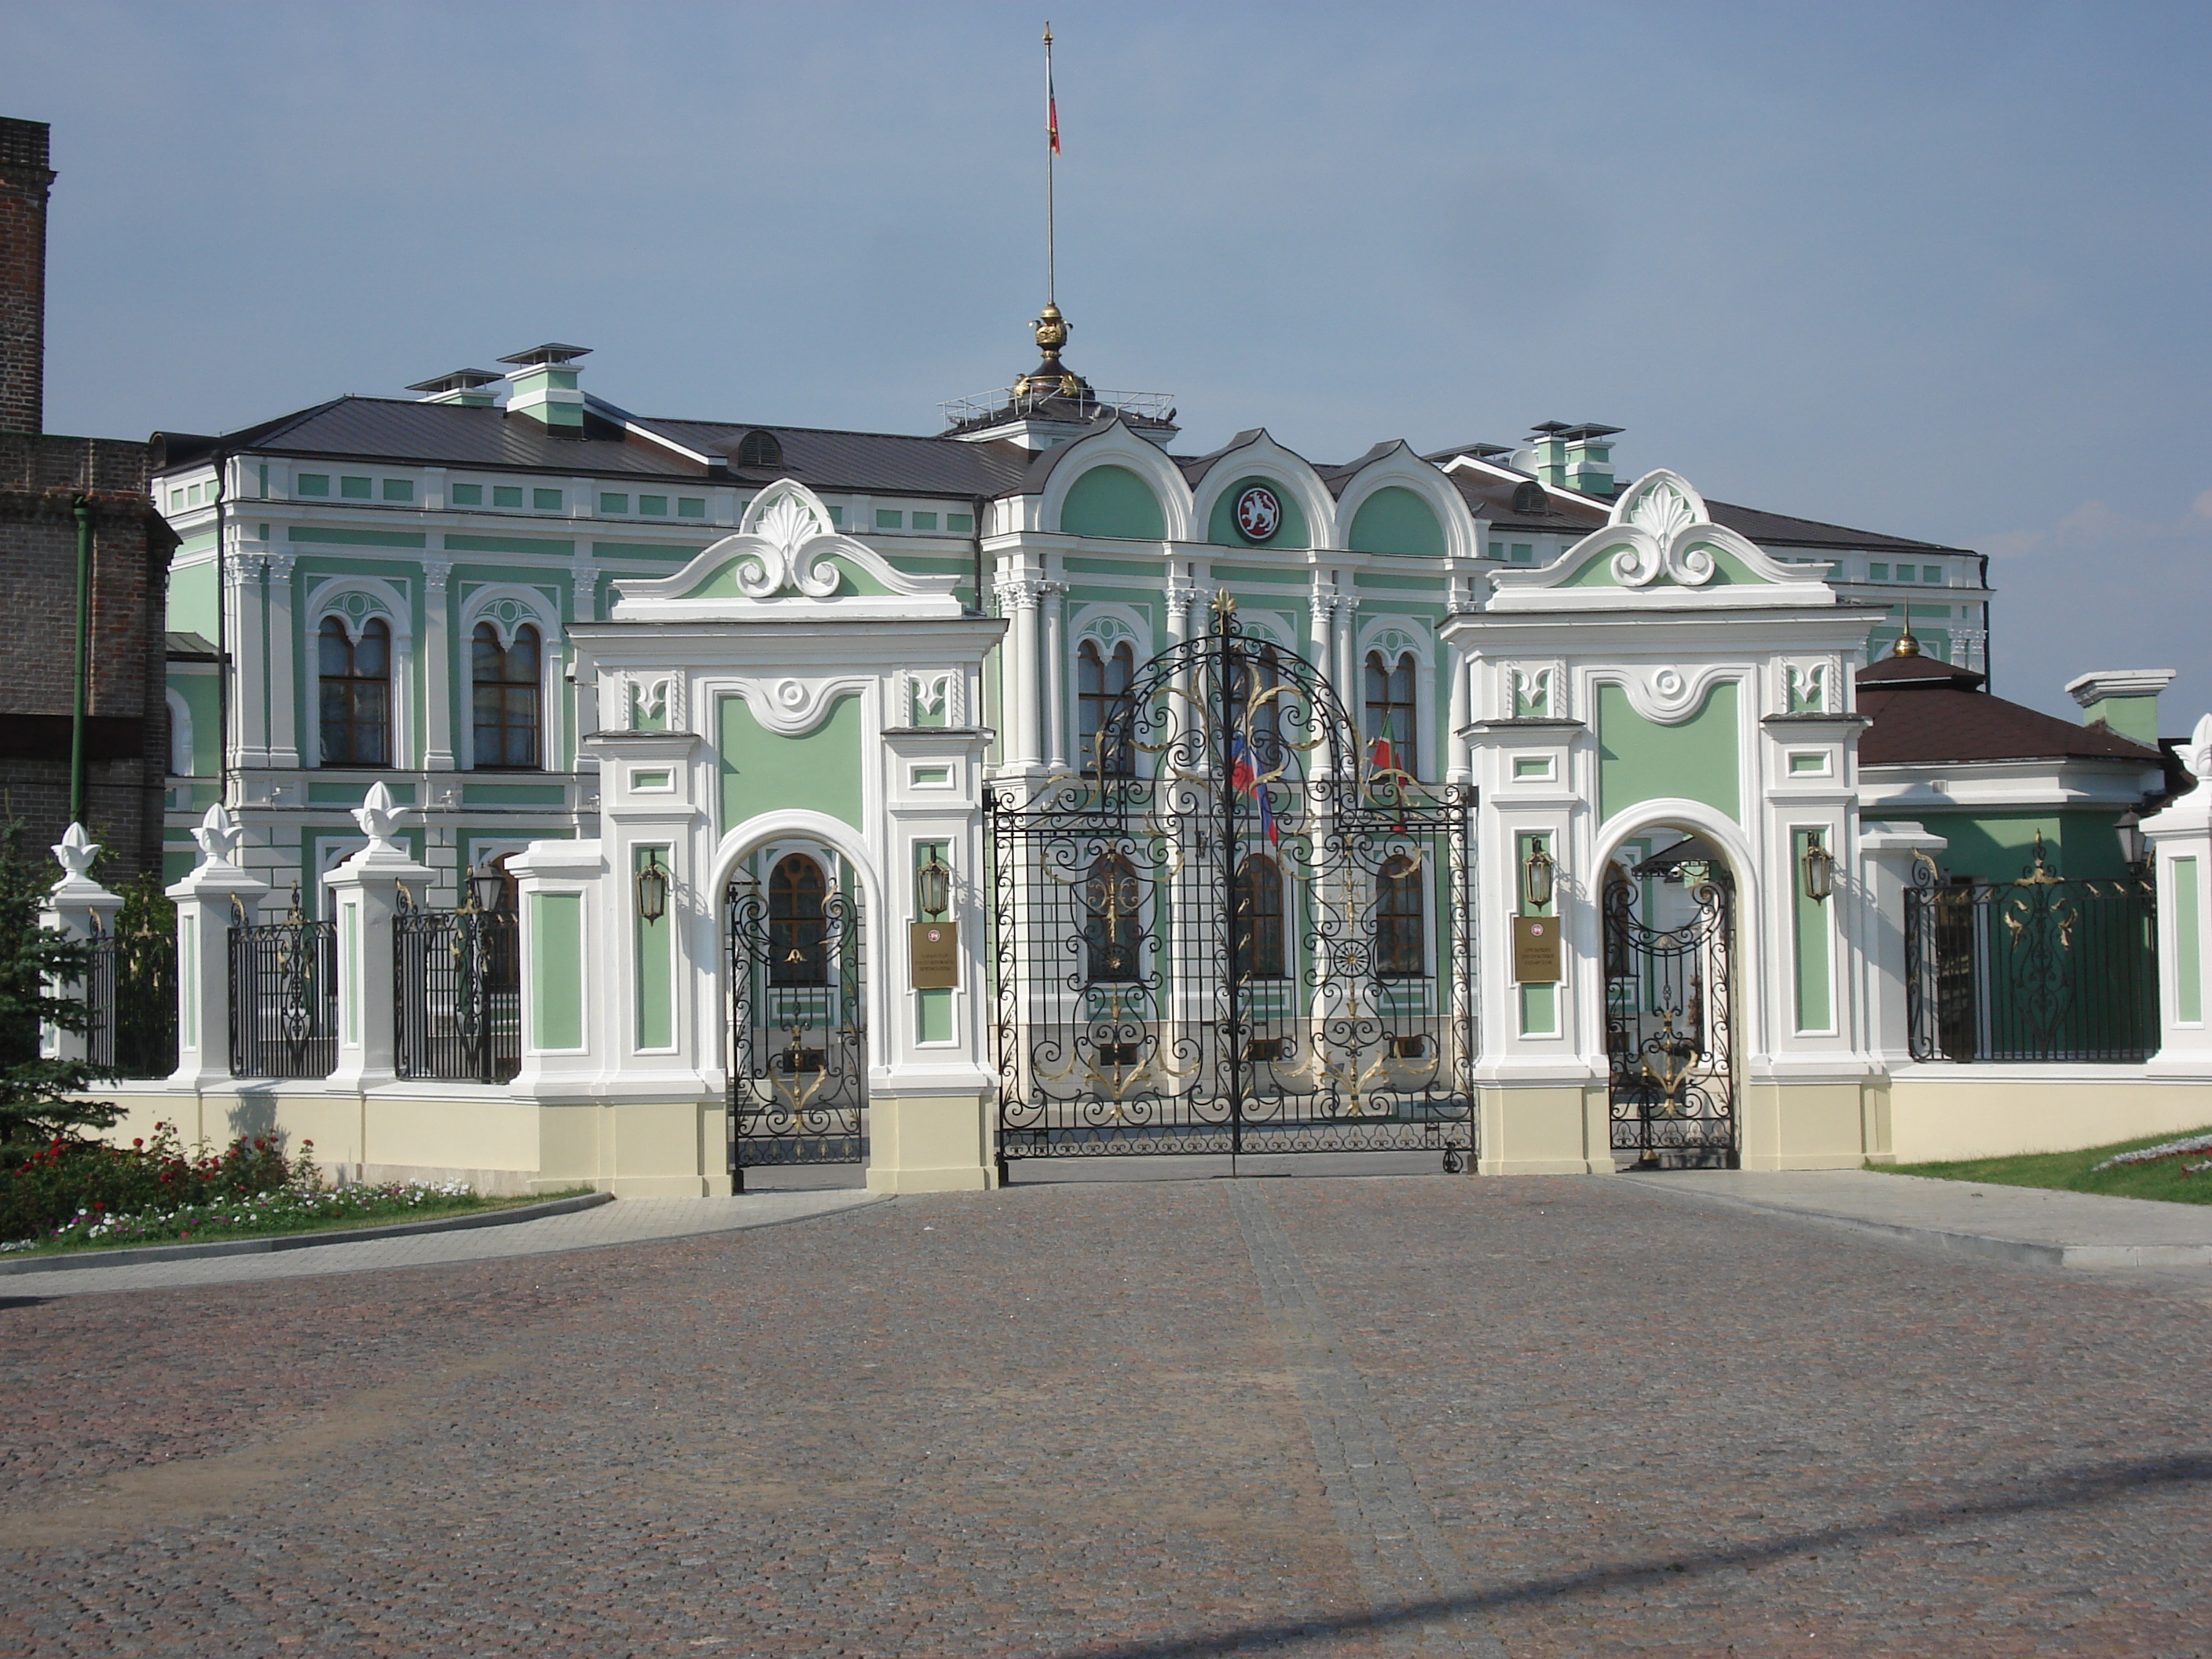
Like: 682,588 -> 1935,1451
1905,849 -> 2159,1064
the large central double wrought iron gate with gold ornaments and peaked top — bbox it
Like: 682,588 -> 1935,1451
984,595 -> 1475,1177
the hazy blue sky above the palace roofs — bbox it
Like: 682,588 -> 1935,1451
0,0 -> 2212,734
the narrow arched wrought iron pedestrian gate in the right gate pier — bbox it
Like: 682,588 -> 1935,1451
1606,854 -> 1741,1170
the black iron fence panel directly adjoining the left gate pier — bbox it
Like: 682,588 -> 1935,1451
391,905 -> 522,1084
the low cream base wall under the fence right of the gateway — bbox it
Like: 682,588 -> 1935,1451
1878,1066 -> 2212,1163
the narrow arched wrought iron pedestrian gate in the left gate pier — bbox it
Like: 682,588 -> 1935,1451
726,854 -> 867,1192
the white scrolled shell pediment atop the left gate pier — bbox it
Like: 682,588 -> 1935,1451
613,478 -> 962,621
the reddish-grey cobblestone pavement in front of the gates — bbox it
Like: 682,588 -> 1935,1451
0,1177 -> 2212,1659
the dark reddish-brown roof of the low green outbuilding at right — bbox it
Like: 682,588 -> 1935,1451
1856,657 -> 2163,765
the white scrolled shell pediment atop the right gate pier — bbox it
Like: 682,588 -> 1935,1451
1489,467 -> 1836,610
